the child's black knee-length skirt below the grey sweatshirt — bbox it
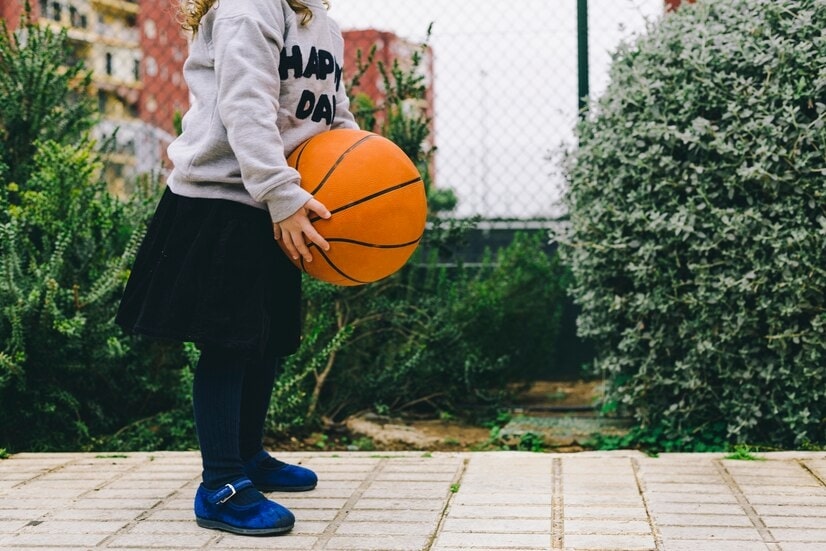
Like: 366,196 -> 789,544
116,189 -> 301,356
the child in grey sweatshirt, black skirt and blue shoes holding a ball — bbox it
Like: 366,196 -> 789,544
117,0 -> 358,535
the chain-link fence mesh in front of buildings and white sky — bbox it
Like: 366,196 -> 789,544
0,0 -> 664,224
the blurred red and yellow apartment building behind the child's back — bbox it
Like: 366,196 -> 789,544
0,0 -> 189,190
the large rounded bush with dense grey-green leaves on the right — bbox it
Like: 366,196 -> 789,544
564,0 -> 826,450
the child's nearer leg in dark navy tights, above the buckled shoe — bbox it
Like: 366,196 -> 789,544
192,347 -> 263,503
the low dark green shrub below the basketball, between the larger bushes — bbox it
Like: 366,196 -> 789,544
271,230 -> 567,433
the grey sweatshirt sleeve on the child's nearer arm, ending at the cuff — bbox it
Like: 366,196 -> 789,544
212,15 -> 312,222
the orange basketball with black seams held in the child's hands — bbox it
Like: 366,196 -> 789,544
279,129 -> 427,285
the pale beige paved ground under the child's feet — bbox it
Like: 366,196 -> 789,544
0,452 -> 826,551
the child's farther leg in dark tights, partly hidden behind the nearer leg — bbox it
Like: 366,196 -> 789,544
238,356 -> 280,461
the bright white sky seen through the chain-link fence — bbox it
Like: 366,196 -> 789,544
330,0 -> 663,217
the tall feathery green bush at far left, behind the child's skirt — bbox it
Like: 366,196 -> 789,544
0,11 -> 183,451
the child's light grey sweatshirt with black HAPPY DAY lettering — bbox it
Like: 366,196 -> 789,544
167,0 -> 358,222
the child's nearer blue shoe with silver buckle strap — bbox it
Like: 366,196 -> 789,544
195,478 -> 295,536
